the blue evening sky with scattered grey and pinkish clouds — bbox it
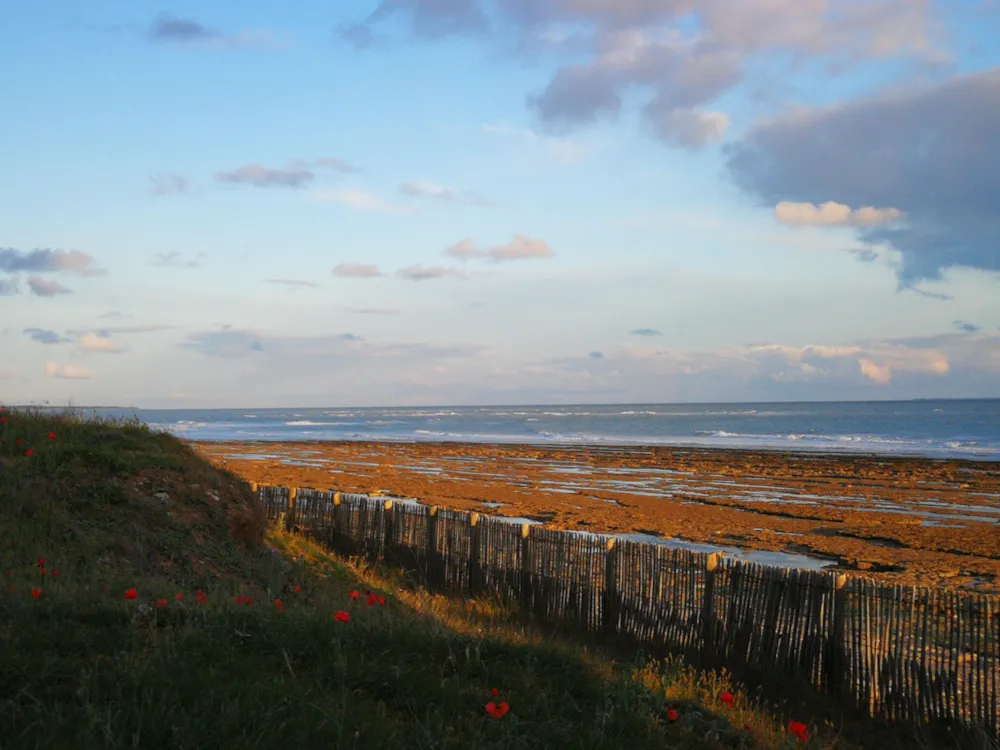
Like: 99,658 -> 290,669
0,0 -> 1000,408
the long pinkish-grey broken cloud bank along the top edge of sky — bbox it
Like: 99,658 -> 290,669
350,0 -> 945,150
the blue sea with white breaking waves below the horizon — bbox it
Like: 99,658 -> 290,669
76,399 -> 1000,461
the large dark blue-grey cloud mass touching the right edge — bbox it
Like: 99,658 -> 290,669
727,68 -> 1000,287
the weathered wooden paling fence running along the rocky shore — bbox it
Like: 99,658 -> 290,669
251,484 -> 1000,740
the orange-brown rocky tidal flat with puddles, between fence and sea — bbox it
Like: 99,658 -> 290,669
194,442 -> 1000,593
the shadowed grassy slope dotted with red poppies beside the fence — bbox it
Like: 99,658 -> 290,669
0,410 -> 988,750
